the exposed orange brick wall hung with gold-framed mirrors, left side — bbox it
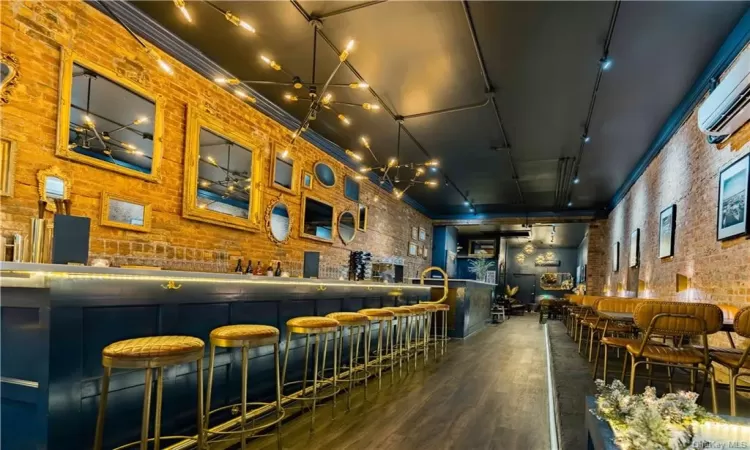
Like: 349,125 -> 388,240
0,1 -> 432,276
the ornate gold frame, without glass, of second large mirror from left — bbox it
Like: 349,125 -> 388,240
182,105 -> 265,231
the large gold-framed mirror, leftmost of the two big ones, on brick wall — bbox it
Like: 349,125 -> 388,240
55,49 -> 165,182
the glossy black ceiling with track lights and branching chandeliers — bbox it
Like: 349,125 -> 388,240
133,1 -> 748,215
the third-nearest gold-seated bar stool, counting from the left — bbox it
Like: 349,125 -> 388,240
281,316 -> 339,432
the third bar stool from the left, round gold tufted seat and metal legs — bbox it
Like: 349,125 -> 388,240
281,316 -> 341,432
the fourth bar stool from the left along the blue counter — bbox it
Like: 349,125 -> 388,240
326,312 -> 370,411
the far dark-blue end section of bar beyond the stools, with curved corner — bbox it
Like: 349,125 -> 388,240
411,278 -> 497,339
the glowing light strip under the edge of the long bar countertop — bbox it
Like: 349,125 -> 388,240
6,270 -> 431,290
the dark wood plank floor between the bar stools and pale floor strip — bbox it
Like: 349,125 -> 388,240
249,315 -> 549,450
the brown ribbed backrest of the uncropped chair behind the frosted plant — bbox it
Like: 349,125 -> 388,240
633,301 -> 724,336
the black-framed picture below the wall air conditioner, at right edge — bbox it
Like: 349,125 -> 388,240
716,155 -> 750,241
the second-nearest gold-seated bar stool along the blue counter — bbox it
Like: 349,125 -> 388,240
203,325 -> 285,450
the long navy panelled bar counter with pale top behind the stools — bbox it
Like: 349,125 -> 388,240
0,263 -> 430,450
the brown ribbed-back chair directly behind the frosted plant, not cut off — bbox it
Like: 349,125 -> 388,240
625,301 -> 724,413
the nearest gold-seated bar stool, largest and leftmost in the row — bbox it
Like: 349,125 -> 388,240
94,336 -> 205,450
